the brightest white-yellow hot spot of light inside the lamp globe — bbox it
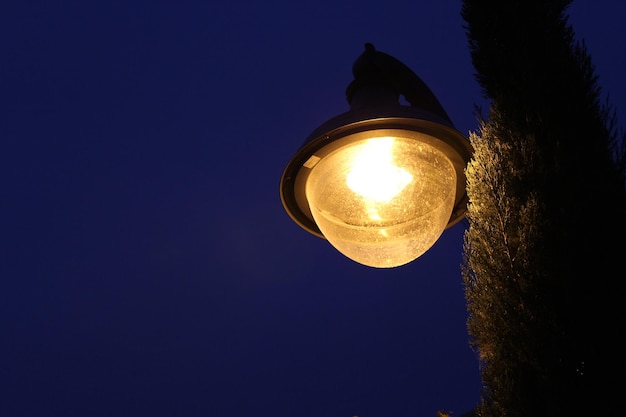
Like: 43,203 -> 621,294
347,137 -> 413,202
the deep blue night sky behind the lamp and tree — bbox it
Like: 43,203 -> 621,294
0,0 -> 626,417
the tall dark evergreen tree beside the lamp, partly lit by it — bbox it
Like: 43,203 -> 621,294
462,0 -> 626,417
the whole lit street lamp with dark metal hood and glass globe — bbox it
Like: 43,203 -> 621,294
280,43 -> 472,268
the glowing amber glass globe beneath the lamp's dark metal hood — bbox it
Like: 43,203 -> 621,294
305,135 -> 456,268
